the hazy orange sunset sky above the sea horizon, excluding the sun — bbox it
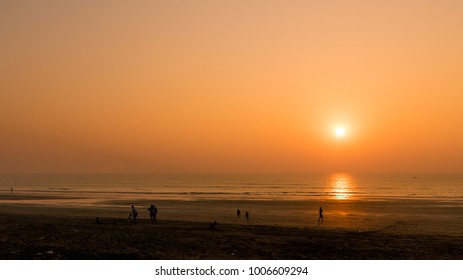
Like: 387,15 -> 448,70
0,0 -> 463,173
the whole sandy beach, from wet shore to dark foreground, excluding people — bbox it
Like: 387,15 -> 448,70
0,197 -> 463,260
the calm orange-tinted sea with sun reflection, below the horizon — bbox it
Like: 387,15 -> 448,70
0,173 -> 463,203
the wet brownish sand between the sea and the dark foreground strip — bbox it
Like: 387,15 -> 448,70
0,194 -> 463,237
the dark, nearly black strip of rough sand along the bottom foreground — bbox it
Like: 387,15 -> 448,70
0,214 -> 463,260
